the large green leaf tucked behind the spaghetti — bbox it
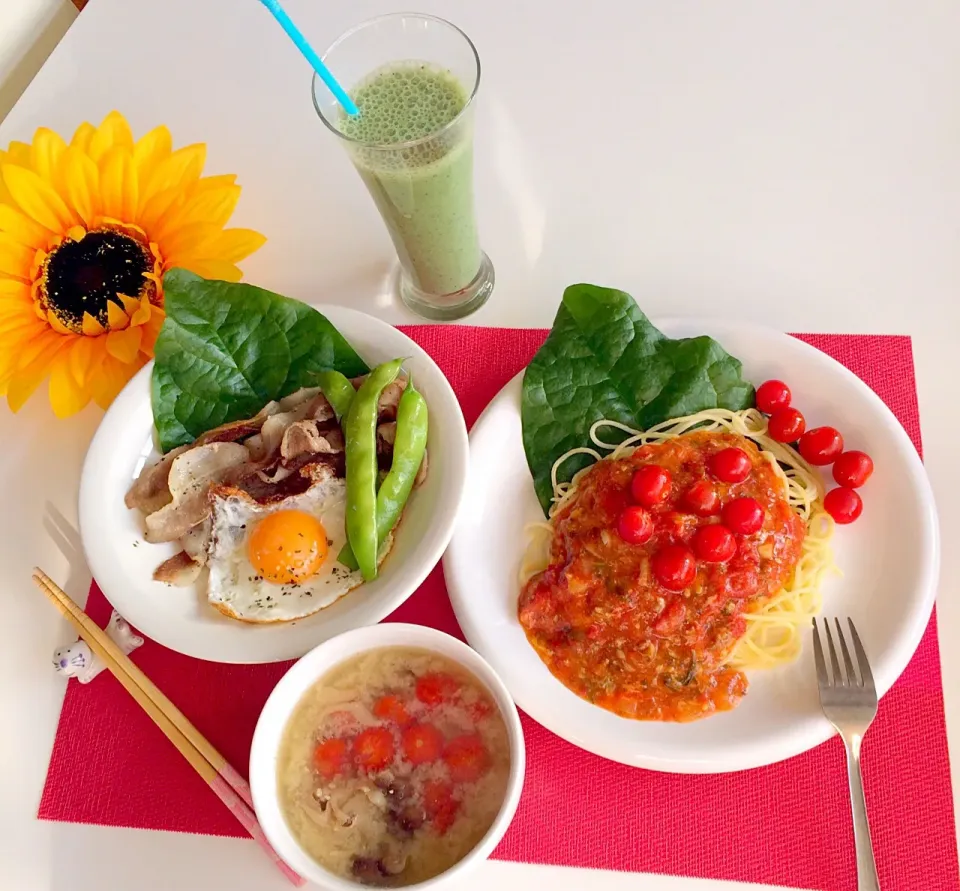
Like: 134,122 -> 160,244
521,284 -> 754,513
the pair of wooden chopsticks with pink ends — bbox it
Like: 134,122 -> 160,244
32,567 -> 306,886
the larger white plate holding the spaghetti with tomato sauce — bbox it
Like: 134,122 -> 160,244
443,319 -> 939,773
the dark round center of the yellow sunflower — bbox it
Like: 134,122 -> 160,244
41,229 -> 153,332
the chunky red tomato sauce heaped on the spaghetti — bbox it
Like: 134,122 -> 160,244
518,432 -> 806,721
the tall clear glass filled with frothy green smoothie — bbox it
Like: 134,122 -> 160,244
313,13 -> 494,320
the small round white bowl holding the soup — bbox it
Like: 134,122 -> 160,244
250,622 -> 526,891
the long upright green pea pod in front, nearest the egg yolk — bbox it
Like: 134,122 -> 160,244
344,359 -> 403,582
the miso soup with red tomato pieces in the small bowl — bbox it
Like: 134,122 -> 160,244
277,647 -> 510,887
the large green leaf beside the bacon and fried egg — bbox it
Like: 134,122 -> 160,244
151,269 -> 369,452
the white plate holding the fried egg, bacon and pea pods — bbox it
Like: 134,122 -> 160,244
80,306 -> 468,663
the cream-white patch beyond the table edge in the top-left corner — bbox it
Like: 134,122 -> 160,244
0,0 -> 77,120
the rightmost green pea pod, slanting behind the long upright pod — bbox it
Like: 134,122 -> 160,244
337,378 -> 428,579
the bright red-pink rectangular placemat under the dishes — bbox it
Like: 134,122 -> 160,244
39,326 -> 960,891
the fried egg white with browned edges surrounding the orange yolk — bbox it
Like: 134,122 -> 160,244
207,477 -> 363,623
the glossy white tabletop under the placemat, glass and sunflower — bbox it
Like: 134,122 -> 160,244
0,0 -> 960,891
